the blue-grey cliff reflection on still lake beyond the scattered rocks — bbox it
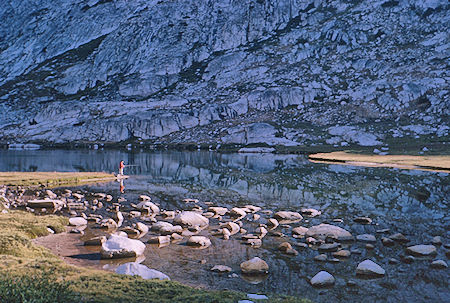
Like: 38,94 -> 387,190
0,150 -> 450,223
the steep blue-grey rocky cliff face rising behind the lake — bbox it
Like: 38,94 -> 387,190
0,0 -> 450,146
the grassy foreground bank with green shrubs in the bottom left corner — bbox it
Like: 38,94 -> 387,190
0,211 -> 309,303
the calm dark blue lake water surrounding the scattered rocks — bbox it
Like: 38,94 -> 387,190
0,150 -> 450,302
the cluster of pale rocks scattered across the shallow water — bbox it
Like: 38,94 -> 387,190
0,187 -> 450,287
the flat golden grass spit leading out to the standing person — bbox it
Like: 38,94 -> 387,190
0,172 -> 115,187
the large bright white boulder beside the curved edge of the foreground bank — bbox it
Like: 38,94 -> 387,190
100,235 -> 145,259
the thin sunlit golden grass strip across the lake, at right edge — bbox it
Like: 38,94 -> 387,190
309,152 -> 450,172
